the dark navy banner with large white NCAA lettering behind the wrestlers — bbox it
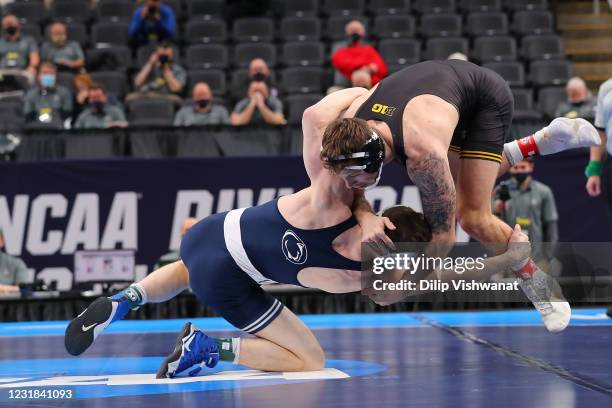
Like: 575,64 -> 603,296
0,152 -> 612,289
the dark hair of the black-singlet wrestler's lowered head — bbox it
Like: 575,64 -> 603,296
382,205 -> 431,242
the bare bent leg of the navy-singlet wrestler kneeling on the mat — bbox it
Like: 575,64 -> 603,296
238,307 -> 325,371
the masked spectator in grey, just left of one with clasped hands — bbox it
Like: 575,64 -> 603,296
174,82 -> 230,126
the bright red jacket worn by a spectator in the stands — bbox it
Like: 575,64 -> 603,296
332,44 -> 389,85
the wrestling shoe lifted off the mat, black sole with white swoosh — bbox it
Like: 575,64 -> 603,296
64,296 -> 130,356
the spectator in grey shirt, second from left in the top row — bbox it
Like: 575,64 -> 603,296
40,23 -> 85,72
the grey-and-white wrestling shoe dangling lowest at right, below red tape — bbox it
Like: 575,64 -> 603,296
519,268 -> 572,333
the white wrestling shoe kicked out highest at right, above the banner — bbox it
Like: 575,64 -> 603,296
534,118 -> 601,156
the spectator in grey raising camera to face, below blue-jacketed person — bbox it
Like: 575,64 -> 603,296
126,43 -> 187,104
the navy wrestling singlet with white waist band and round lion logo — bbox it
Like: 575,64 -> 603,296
181,199 -> 361,333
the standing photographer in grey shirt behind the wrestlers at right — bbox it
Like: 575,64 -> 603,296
493,157 -> 559,272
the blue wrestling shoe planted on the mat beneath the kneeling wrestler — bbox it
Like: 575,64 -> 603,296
156,323 -> 219,378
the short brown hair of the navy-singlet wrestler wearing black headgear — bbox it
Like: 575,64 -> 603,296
321,118 -> 372,173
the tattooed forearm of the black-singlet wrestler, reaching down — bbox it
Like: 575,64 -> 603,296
406,148 -> 456,256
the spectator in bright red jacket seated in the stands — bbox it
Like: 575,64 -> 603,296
332,20 -> 388,85
